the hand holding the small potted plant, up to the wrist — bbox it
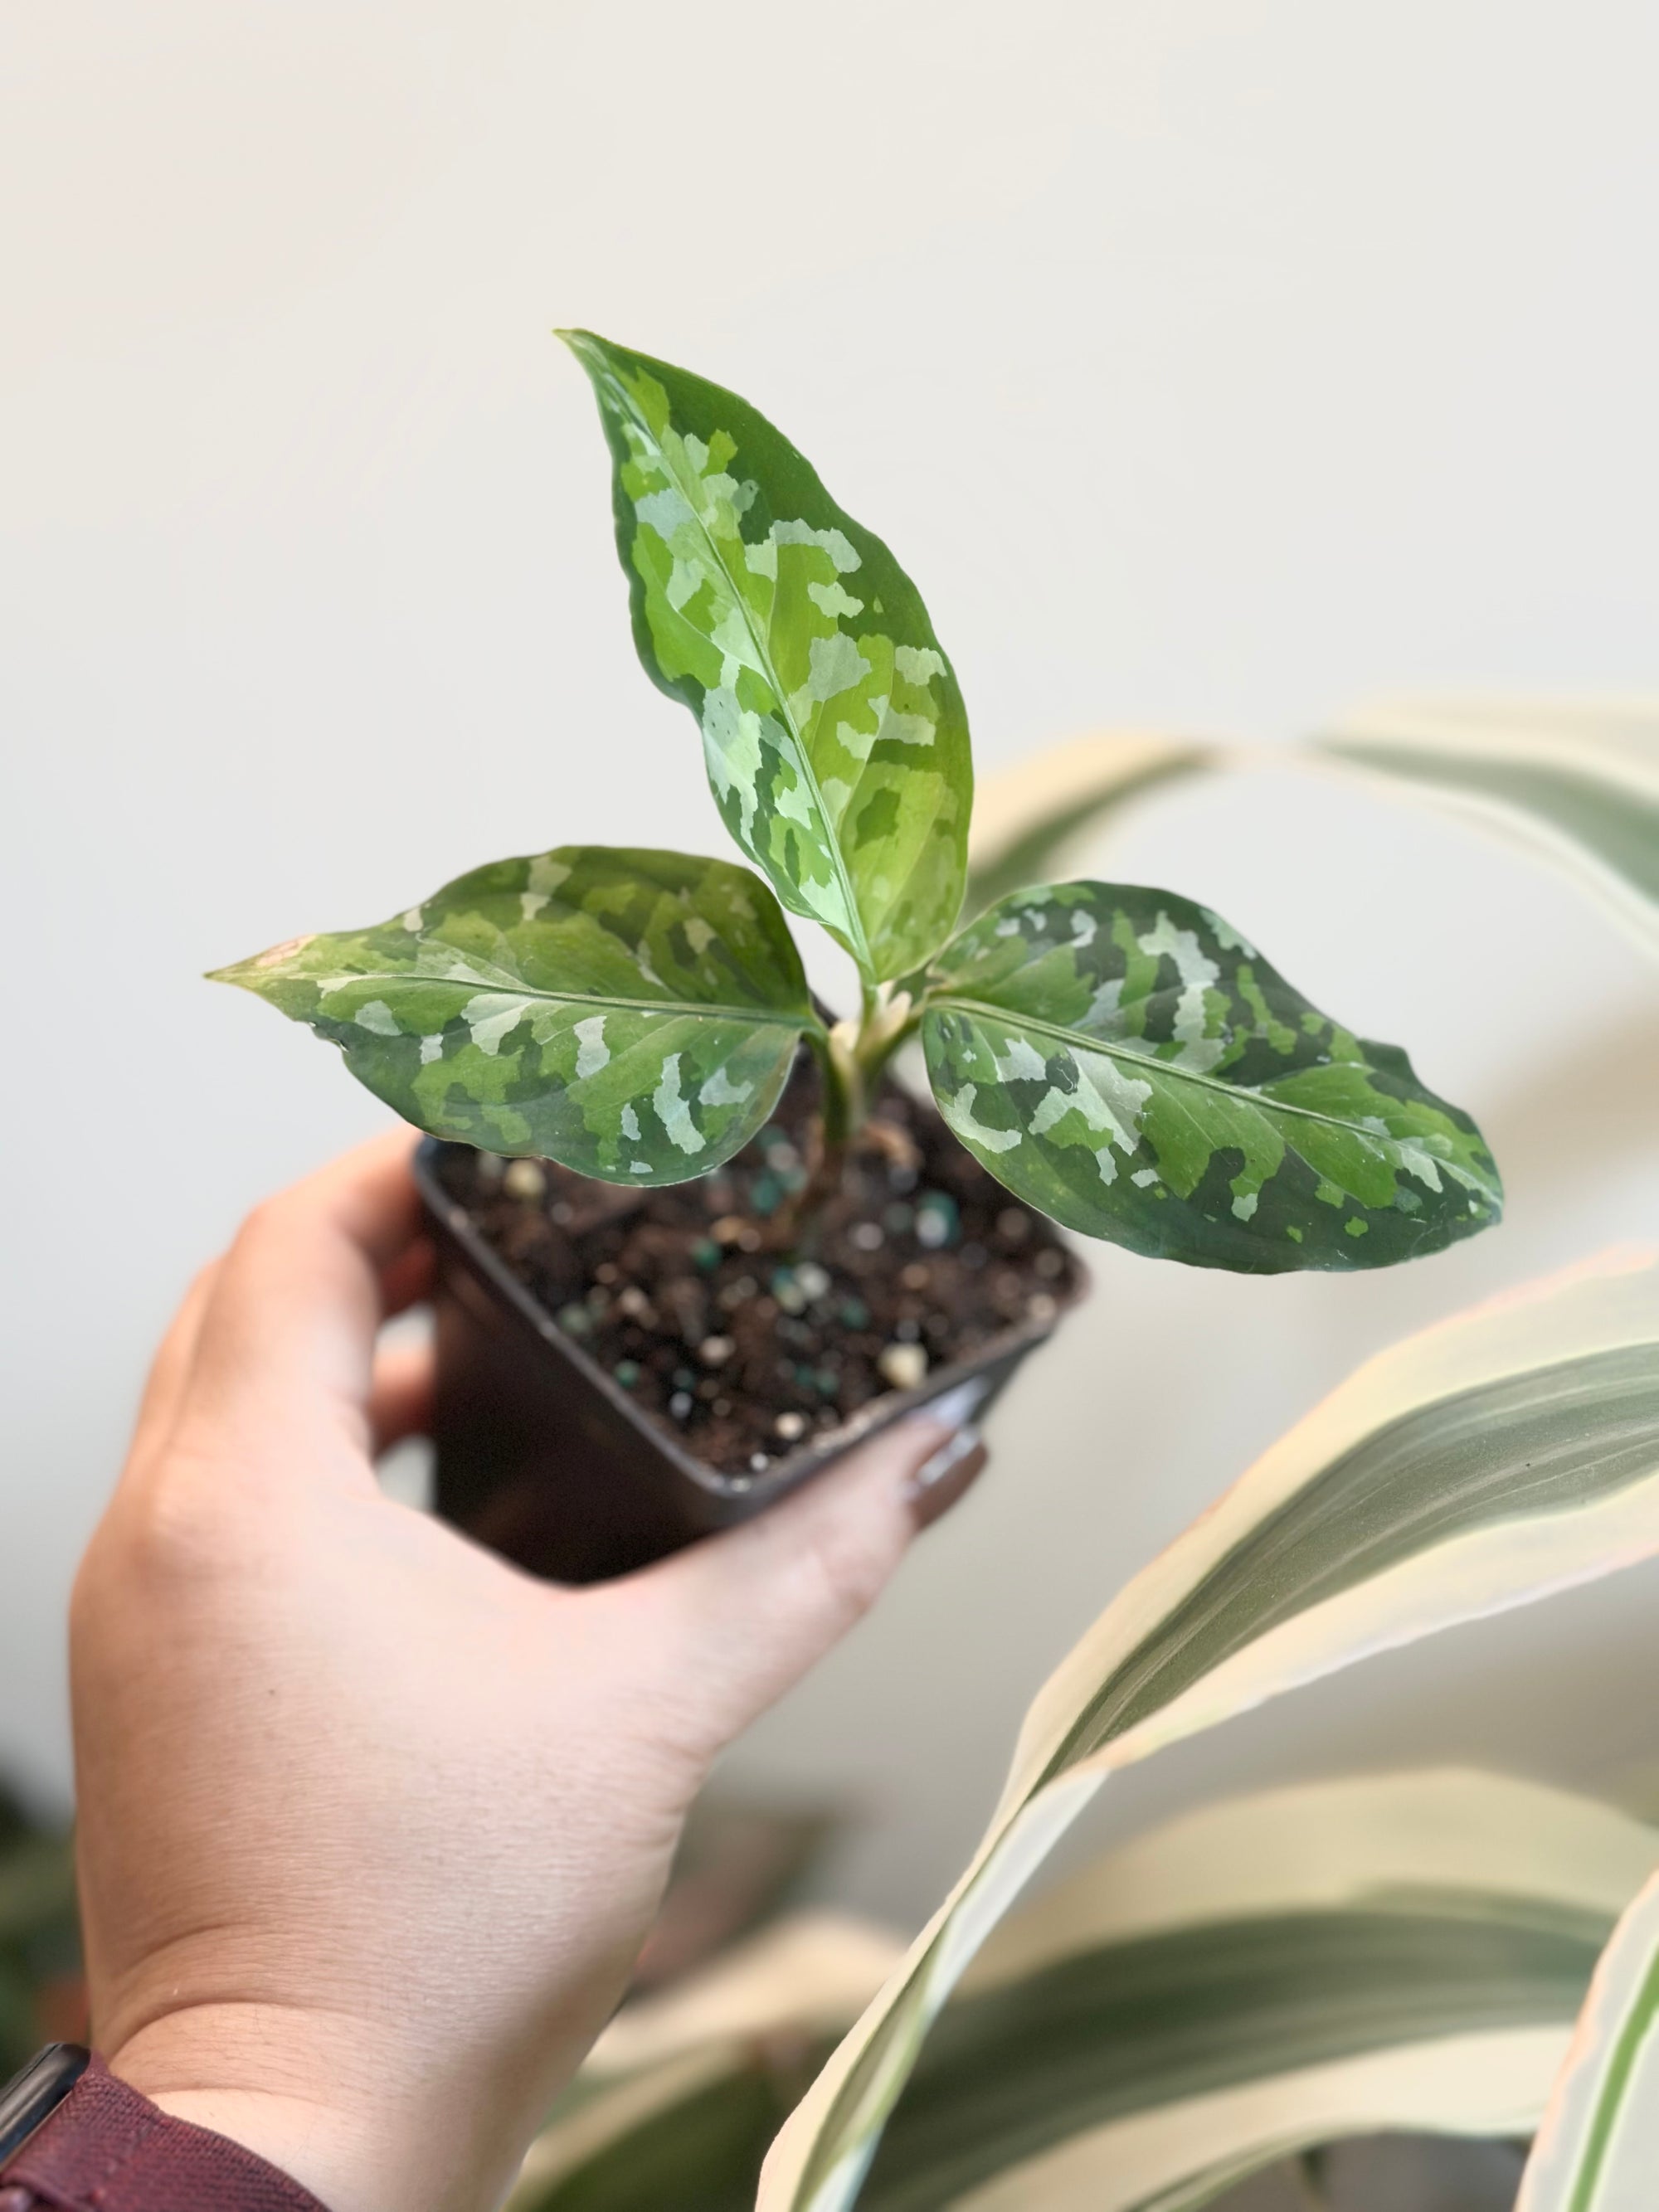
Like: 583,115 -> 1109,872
71,1133 -> 985,2212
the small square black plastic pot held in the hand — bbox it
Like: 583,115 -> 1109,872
416,1140 -> 1088,1582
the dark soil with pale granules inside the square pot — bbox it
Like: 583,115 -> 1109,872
438,1066 -> 1084,1475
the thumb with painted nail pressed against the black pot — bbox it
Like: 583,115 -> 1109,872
633,1380 -> 985,1757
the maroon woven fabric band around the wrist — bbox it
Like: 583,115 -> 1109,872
0,2059 -> 323,2212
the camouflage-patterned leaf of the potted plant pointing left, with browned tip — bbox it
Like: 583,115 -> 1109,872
215,845 -> 819,1186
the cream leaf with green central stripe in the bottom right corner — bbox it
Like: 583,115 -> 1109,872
1515,1876 -> 1659,2212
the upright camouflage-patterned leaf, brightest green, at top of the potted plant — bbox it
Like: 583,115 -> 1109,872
562,329 -> 973,980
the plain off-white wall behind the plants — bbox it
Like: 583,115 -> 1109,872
0,0 -> 1659,1916
